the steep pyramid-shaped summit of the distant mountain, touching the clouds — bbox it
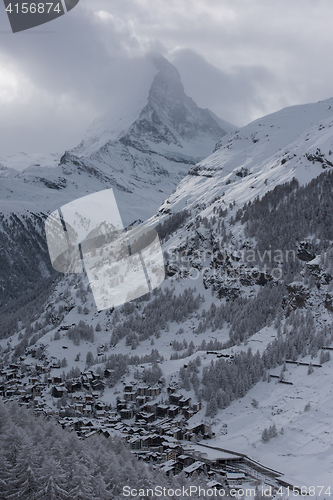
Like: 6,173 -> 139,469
74,56 -> 234,160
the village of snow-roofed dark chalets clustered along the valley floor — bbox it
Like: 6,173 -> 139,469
0,353 -> 290,488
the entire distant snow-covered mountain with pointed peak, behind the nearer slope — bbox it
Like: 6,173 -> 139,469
0,57 -> 235,225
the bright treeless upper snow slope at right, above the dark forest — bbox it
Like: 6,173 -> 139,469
158,98 -> 333,219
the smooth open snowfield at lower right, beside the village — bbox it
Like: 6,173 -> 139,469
197,357 -> 333,486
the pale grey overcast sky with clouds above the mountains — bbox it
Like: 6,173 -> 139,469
0,0 -> 333,157
